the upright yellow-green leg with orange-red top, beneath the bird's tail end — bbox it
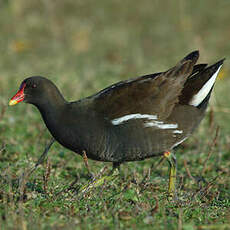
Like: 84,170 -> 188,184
164,152 -> 176,199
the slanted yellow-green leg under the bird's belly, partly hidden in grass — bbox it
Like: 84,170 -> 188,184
78,163 -> 120,194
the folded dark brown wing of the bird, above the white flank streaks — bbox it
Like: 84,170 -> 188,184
92,51 -> 199,121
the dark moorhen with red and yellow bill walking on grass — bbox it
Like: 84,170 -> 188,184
9,50 -> 225,197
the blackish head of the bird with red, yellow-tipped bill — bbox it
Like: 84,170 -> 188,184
9,76 -> 63,105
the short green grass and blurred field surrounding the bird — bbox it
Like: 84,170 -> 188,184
0,0 -> 230,230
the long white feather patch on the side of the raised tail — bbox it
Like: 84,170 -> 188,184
189,65 -> 222,106
